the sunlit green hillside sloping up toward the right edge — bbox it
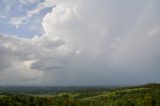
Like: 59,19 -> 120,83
79,84 -> 160,106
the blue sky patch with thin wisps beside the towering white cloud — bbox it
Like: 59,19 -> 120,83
0,0 -> 51,38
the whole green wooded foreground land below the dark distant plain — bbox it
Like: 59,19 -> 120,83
0,84 -> 160,106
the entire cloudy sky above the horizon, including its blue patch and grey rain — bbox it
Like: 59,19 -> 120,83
0,0 -> 160,86
